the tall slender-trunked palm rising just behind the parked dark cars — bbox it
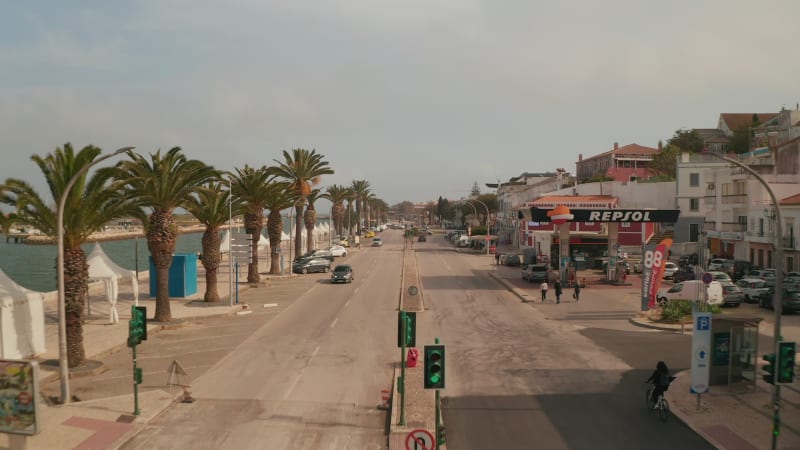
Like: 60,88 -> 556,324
271,148 -> 333,255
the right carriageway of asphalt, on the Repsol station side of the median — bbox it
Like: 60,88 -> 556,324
417,239 -> 712,450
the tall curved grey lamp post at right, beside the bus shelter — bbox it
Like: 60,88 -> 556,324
704,152 -> 784,448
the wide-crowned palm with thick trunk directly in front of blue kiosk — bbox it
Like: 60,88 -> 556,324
109,147 -> 220,322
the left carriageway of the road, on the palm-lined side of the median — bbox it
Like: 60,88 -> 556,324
122,236 -> 402,449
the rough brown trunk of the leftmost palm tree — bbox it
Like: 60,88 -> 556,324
64,247 -> 89,367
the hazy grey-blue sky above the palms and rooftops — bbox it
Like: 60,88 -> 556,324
0,0 -> 800,208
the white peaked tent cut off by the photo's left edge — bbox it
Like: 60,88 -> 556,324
0,270 -> 45,359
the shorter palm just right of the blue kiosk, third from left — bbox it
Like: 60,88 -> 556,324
184,182 -> 245,302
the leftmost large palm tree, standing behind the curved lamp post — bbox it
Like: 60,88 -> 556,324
0,143 -> 136,367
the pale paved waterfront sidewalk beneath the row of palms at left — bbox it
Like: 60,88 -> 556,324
0,256 -> 289,450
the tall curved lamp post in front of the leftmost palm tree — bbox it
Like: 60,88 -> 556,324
56,147 -> 132,404
